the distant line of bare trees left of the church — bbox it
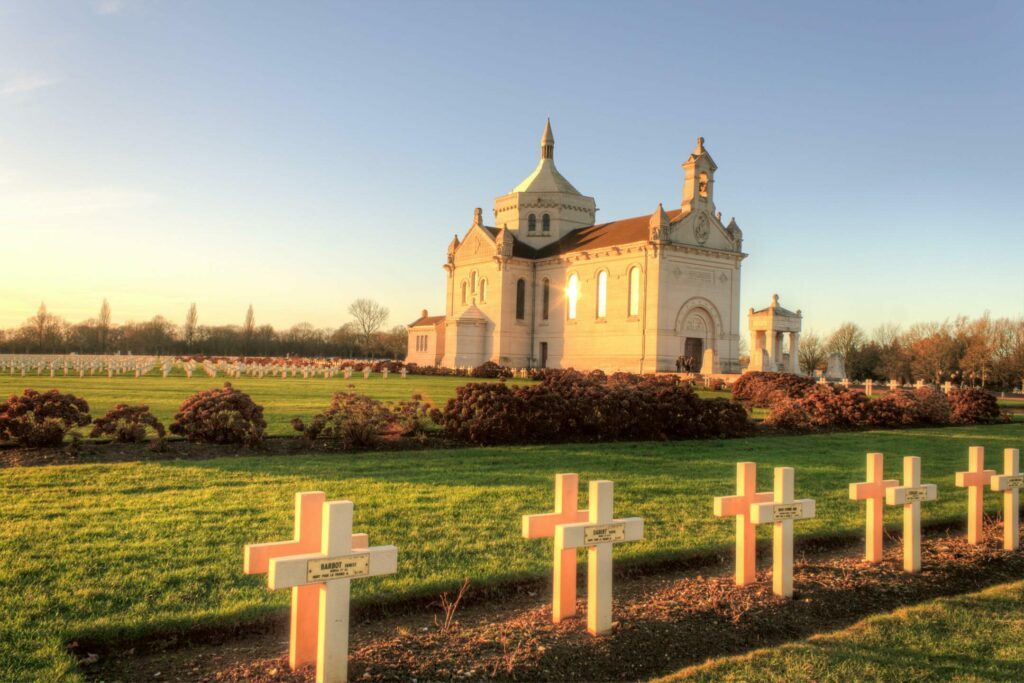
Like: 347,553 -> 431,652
0,299 -> 409,358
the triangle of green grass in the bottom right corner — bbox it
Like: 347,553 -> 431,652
660,581 -> 1024,683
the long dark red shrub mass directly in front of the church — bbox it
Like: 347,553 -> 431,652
434,370 -> 750,444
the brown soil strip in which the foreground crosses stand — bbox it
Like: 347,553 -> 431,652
83,520 -> 1024,683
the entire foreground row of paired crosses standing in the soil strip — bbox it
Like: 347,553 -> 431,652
245,447 -> 1024,683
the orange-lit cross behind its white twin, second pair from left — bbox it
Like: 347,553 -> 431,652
522,474 -> 588,624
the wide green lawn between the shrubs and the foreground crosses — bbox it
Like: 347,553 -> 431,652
0,419 -> 1024,680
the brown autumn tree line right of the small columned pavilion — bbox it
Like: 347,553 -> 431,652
799,313 -> 1024,389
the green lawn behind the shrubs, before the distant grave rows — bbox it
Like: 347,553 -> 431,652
0,370 -> 731,436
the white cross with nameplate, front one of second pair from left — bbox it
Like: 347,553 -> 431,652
555,480 -> 643,636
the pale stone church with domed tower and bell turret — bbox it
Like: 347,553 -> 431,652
406,121 -> 746,373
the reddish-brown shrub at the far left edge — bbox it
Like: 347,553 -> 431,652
0,389 -> 90,447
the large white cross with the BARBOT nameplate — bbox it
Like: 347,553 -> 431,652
246,494 -> 398,683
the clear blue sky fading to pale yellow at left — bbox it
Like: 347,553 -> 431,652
0,0 -> 1024,339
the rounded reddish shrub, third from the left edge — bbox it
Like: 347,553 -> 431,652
171,382 -> 266,446
